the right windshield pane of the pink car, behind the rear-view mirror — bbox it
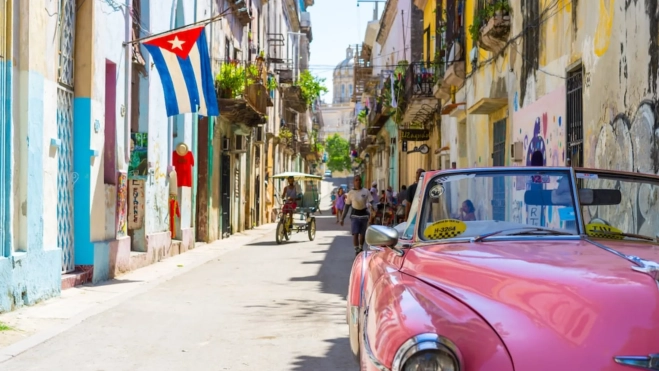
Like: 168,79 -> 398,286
577,172 -> 659,244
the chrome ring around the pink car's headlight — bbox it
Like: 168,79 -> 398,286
391,333 -> 462,371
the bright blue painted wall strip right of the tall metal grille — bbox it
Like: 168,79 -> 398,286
73,97 -> 94,265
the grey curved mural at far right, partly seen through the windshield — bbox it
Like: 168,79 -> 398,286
587,100 -> 659,236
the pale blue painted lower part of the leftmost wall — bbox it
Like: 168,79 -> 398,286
0,69 -> 62,312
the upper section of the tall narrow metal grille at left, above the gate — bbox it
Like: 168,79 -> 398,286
57,0 -> 76,89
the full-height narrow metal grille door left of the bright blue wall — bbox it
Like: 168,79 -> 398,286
57,0 -> 77,273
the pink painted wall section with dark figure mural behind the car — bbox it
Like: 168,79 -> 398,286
512,85 -> 565,166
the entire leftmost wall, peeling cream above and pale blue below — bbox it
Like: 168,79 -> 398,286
0,1 -> 62,312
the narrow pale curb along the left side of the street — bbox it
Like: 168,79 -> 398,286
0,223 -> 277,363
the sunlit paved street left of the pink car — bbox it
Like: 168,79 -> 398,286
0,179 -> 356,371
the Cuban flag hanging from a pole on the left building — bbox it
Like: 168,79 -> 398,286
142,26 -> 220,117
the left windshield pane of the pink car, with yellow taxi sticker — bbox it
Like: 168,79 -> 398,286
418,169 -> 578,240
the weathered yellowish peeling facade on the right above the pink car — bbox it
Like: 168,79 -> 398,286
454,0 -> 659,173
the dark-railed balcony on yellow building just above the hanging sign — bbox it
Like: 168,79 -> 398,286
403,62 -> 444,124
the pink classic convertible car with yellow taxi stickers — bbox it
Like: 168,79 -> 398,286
347,167 -> 659,371
